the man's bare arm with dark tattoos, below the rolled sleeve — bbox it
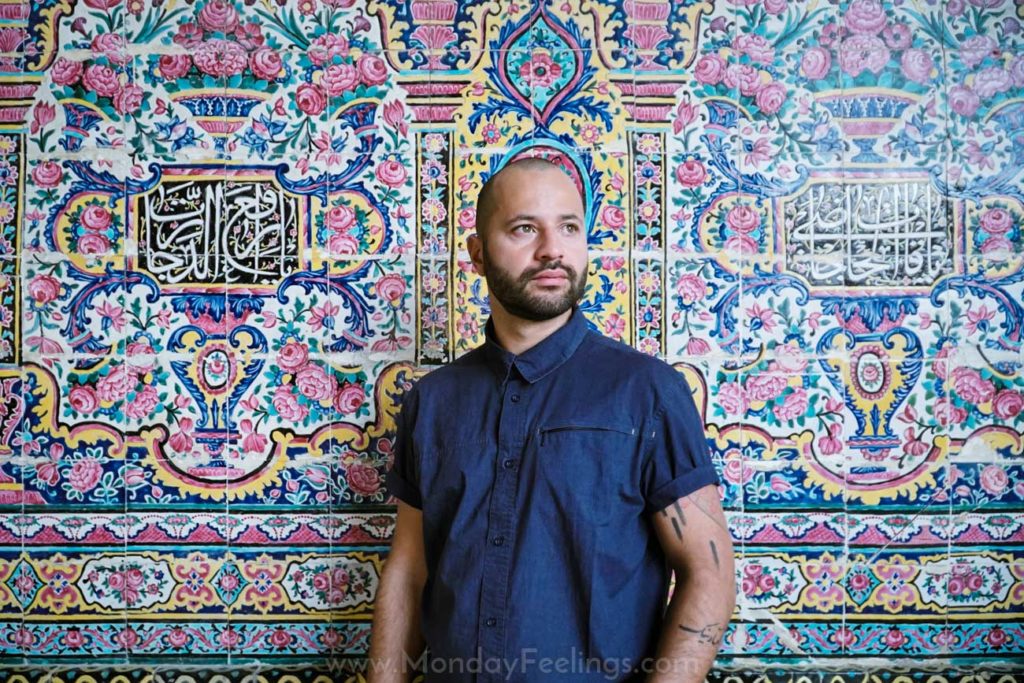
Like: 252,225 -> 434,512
648,486 -> 736,683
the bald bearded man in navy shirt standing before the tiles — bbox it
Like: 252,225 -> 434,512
370,159 -> 734,683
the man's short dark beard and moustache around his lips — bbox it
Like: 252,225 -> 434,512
483,250 -> 587,323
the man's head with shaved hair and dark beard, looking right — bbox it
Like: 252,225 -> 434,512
468,159 -> 587,321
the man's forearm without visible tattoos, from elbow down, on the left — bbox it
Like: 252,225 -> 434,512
369,564 -> 424,683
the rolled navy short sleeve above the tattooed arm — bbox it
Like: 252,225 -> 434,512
642,370 -> 718,513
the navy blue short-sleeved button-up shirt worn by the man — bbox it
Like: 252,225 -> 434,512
387,309 -> 718,681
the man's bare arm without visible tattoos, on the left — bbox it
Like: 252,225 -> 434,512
369,501 -> 427,683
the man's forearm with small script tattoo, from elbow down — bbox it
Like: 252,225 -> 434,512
648,571 -> 735,683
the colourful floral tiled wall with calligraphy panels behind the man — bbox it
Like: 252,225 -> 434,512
0,0 -> 1024,683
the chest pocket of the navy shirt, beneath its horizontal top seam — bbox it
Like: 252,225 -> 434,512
536,422 -> 639,525
